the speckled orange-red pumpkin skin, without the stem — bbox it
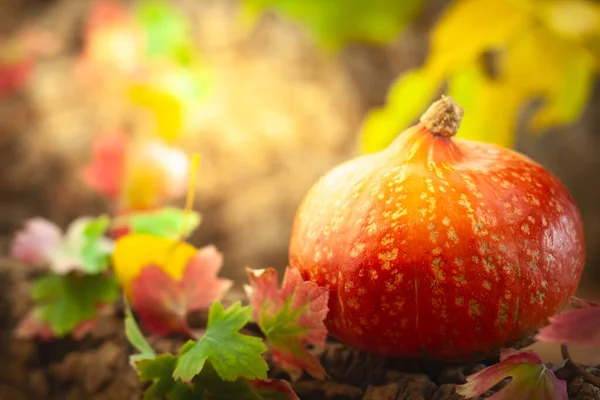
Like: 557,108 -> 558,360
289,123 -> 585,361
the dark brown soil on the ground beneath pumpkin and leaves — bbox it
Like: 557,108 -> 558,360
0,259 -> 600,400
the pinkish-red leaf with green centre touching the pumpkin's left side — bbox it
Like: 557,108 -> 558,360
246,267 -> 329,380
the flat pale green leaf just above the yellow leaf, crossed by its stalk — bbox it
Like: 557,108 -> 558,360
118,207 -> 201,239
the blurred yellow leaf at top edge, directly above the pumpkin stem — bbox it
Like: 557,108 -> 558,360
427,0 -> 531,72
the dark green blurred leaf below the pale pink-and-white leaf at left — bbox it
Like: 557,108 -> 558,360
33,274 -> 119,336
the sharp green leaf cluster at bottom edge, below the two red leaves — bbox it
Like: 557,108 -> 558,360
125,302 -> 297,400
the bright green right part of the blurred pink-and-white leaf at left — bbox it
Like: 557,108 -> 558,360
81,215 -> 112,274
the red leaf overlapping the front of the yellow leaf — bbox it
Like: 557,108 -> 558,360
131,246 -> 232,336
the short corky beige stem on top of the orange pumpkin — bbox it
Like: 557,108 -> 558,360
421,95 -> 464,137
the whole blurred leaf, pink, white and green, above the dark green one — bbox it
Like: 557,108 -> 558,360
11,216 -> 114,274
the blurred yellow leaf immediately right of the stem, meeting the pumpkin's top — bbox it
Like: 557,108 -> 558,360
448,63 -> 522,148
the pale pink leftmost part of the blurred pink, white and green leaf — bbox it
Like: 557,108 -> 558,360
11,218 -> 62,265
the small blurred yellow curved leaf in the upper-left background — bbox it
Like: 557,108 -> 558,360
129,85 -> 183,141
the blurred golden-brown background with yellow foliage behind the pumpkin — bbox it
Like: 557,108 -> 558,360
0,0 -> 600,304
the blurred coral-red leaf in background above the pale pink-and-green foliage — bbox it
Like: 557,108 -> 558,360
83,131 -> 127,199
